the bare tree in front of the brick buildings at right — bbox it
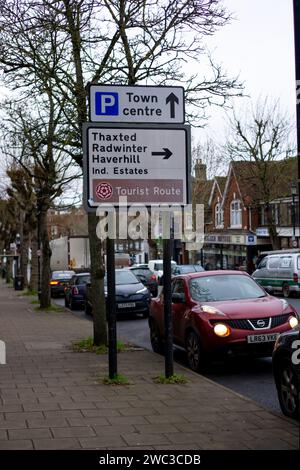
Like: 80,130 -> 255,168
224,98 -> 293,249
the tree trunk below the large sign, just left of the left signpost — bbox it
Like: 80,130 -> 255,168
88,213 -> 107,346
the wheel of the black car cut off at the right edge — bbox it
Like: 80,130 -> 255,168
278,359 -> 299,418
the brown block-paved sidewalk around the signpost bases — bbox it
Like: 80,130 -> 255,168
0,284 -> 298,450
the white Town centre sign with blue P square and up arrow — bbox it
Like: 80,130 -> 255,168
89,85 -> 184,124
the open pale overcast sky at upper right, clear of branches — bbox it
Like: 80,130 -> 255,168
193,0 -> 296,143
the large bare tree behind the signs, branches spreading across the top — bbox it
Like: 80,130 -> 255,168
0,0 -> 241,344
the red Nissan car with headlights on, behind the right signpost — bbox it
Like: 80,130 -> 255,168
149,271 -> 298,371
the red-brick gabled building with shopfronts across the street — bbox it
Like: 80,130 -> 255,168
194,158 -> 299,272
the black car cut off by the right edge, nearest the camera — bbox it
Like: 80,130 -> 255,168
273,326 -> 300,419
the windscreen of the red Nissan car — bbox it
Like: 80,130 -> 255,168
189,274 -> 266,302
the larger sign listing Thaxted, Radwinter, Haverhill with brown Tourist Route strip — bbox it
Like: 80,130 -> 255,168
83,123 -> 190,211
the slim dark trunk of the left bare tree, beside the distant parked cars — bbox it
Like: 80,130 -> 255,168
39,208 -> 51,308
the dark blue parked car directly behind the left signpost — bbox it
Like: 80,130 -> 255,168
85,268 -> 151,318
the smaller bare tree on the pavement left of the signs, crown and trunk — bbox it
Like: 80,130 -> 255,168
2,97 -> 77,308
